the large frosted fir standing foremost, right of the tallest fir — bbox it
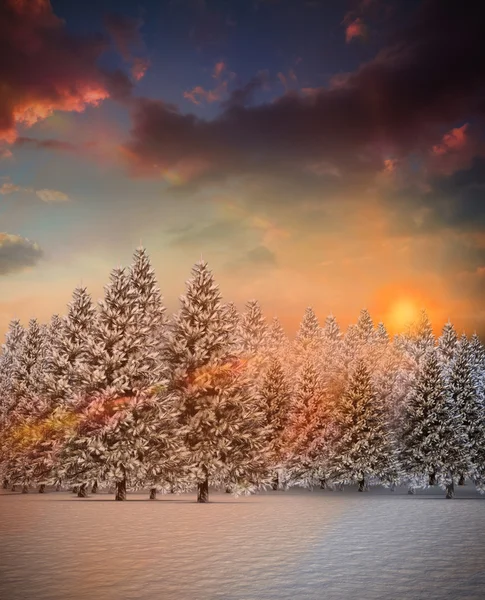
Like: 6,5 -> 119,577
164,261 -> 266,502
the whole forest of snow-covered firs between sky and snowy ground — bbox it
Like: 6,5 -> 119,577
0,248 -> 485,502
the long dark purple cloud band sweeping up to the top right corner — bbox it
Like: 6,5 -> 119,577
120,0 -> 485,188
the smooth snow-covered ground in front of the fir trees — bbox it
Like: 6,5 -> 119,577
0,486 -> 485,600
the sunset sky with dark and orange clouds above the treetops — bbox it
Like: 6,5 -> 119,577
0,0 -> 485,337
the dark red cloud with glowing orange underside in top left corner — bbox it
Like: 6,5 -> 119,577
0,0 -> 145,143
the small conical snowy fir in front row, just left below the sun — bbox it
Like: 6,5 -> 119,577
330,360 -> 400,492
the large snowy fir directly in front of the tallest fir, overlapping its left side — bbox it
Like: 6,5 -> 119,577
59,266 -> 166,499
